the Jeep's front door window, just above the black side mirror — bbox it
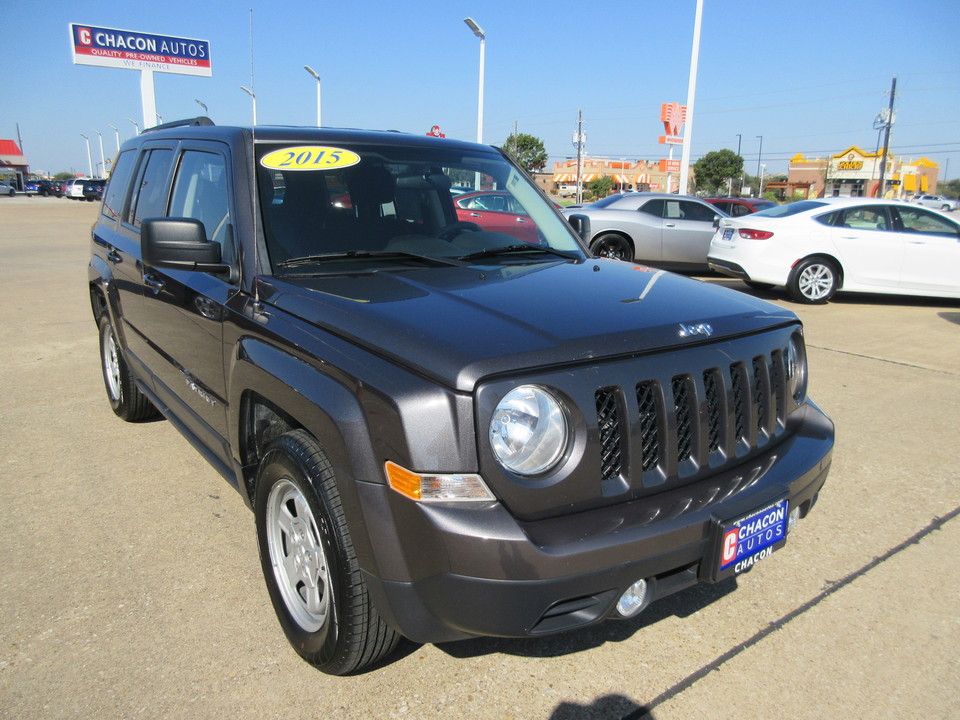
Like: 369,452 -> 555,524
169,150 -> 232,261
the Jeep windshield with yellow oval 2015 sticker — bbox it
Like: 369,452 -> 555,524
257,143 -> 584,275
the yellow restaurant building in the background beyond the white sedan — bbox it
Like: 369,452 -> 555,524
778,145 -> 940,199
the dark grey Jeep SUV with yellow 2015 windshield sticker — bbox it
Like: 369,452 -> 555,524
88,118 -> 834,674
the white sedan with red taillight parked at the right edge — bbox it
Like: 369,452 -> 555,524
708,198 -> 960,303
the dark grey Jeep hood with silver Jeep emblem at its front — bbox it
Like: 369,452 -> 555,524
261,259 -> 797,392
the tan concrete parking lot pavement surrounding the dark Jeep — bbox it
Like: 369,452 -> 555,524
0,196 -> 960,720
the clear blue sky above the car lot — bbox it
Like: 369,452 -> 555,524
0,0 -> 960,178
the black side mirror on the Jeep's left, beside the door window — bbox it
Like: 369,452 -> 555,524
140,218 -> 231,272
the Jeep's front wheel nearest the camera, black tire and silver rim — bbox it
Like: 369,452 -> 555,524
254,430 -> 400,675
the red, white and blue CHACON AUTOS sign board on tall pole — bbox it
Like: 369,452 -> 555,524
70,23 -> 213,77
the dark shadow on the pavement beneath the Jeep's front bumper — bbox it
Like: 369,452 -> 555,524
437,577 -> 737,660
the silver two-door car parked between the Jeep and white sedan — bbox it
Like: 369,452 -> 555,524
564,193 -> 729,270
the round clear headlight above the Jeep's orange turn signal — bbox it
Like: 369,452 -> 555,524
490,385 -> 567,475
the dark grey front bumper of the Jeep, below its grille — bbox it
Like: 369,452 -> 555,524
360,404 -> 833,642
